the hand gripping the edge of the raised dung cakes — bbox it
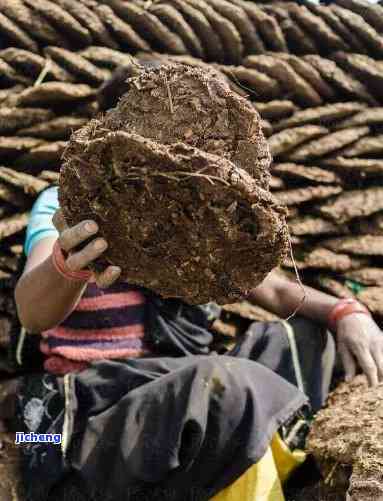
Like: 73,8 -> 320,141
53,209 -> 121,288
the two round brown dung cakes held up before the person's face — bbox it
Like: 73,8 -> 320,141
59,65 -> 287,303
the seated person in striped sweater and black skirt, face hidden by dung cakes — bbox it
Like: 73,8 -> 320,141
15,70 -> 383,501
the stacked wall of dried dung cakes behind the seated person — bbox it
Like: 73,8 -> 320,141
0,0 -> 383,352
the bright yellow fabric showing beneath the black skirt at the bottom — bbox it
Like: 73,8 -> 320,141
211,433 -> 306,501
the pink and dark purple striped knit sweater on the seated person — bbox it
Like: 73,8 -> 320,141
40,282 -> 150,374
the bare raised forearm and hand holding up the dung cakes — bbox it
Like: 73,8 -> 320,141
15,211 -> 121,332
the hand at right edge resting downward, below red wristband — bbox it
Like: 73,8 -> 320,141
336,313 -> 383,386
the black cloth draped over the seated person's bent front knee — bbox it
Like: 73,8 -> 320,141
68,355 -> 306,501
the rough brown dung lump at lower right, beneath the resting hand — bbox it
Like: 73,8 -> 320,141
308,376 -> 383,501
